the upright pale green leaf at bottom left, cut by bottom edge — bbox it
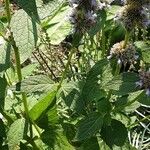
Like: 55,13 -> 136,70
8,118 -> 25,150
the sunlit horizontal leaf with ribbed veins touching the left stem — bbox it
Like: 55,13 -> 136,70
21,75 -> 55,93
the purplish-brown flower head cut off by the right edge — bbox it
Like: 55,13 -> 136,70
136,71 -> 150,96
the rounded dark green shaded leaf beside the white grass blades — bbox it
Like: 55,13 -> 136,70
101,119 -> 128,148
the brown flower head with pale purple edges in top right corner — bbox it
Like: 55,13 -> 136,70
115,0 -> 150,31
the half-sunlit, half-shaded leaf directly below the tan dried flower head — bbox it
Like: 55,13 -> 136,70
104,72 -> 139,95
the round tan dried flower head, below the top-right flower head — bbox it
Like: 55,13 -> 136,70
108,41 -> 138,65
